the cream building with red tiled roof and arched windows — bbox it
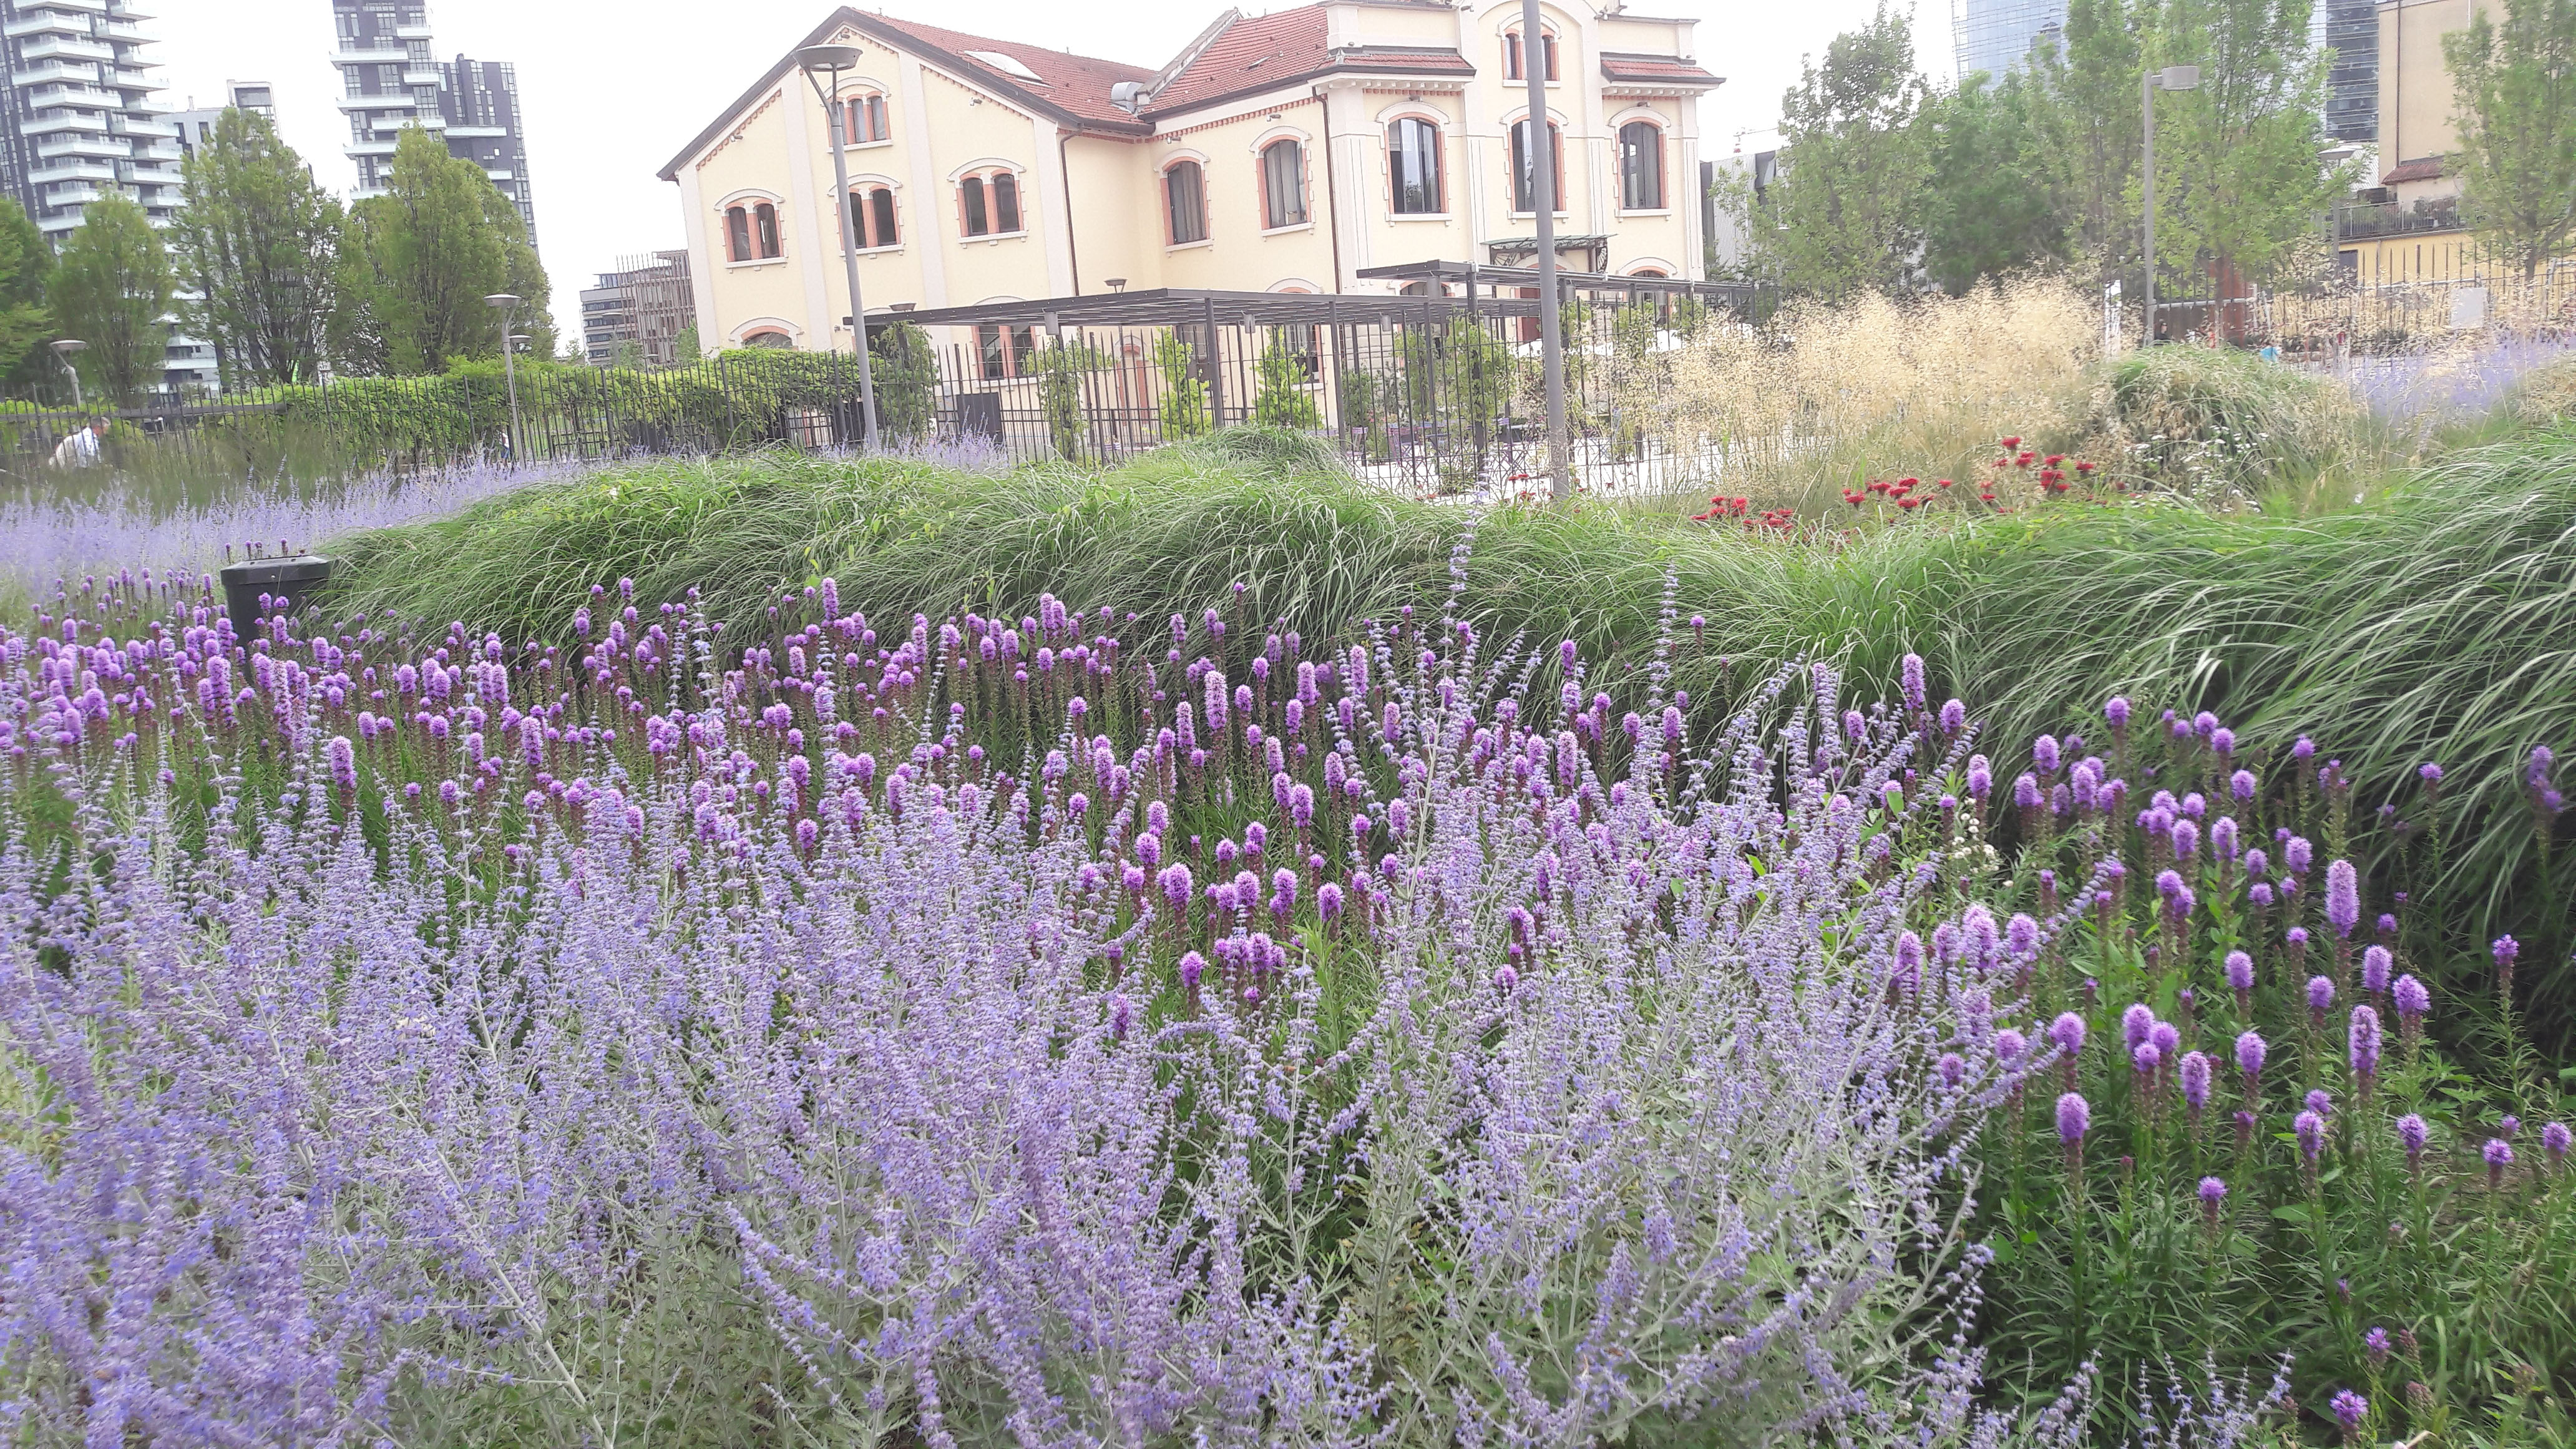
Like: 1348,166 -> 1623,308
662,0 -> 1718,351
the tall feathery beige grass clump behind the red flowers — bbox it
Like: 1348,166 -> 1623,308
1659,278 -> 2102,515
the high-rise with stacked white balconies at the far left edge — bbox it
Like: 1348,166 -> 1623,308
0,0 -> 180,242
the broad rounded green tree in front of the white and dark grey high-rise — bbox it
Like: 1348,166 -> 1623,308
333,126 -> 554,374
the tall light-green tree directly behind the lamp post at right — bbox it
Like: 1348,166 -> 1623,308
2149,0 -> 2352,296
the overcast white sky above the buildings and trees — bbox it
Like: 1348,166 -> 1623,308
147,0 -> 1950,338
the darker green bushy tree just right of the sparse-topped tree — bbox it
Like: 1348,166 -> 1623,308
1921,70 -> 2069,296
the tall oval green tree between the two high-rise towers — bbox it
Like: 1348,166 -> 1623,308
173,111 -> 343,387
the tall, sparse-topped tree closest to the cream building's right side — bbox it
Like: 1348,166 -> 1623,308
1718,5 -> 1927,296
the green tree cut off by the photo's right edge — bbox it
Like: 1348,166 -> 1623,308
2442,0 -> 2576,278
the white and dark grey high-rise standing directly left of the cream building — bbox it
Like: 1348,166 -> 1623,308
332,0 -> 536,242
